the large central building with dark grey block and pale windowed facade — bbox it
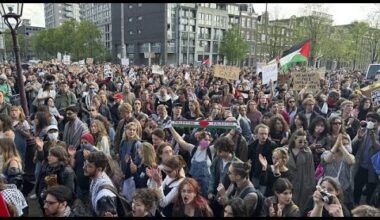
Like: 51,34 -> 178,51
111,3 -> 257,65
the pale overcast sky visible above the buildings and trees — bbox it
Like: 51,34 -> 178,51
11,3 -> 375,27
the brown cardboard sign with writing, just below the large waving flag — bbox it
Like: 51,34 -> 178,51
292,72 -> 320,93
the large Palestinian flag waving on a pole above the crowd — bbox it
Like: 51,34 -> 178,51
269,40 -> 310,70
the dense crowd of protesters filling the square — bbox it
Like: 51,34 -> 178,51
0,61 -> 380,217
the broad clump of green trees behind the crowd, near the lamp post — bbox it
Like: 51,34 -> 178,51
31,19 -> 110,61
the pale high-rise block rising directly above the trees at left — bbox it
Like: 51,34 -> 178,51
44,3 -> 80,28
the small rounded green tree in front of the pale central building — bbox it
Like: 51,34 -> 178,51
220,25 -> 249,65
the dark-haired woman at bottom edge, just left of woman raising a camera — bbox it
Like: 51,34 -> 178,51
265,178 -> 301,217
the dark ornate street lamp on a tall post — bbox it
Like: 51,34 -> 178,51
0,3 -> 29,115
